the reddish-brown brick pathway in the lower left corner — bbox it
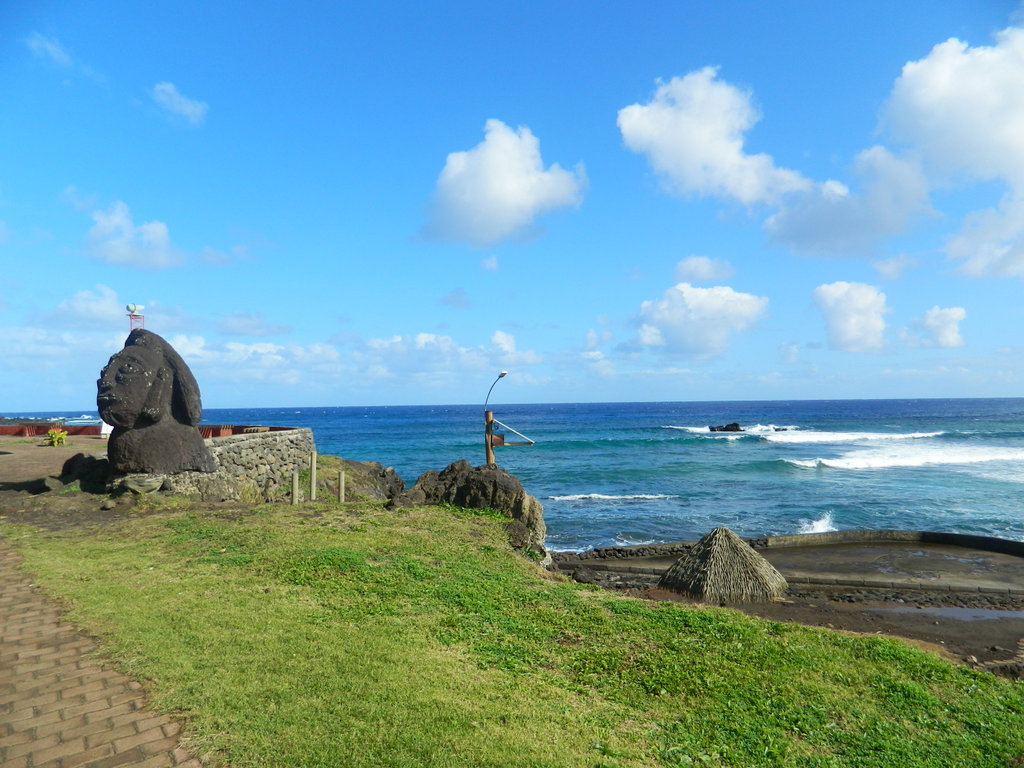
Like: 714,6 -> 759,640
0,541 -> 202,768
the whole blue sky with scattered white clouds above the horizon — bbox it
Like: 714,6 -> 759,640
0,0 -> 1024,412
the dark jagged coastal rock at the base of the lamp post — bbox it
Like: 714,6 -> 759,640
392,459 -> 551,568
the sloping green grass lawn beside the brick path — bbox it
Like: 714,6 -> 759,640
0,503 -> 1024,768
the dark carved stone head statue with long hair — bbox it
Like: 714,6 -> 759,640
96,328 -> 215,475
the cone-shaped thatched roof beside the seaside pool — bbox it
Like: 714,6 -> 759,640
658,527 -> 788,603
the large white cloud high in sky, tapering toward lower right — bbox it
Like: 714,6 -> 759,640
618,67 -> 809,205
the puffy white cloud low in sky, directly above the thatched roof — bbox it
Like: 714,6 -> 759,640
638,283 -> 768,355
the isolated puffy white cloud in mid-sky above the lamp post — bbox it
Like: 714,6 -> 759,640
427,120 -> 586,246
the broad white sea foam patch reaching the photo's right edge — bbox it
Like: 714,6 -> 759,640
782,443 -> 1024,469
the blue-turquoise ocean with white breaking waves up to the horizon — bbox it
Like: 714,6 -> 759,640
10,398 -> 1024,551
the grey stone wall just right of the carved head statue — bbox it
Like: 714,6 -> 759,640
157,427 -> 314,503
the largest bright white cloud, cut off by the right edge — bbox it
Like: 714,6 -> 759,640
884,28 -> 1024,276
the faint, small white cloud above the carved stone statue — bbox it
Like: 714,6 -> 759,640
86,200 -> 181,269
